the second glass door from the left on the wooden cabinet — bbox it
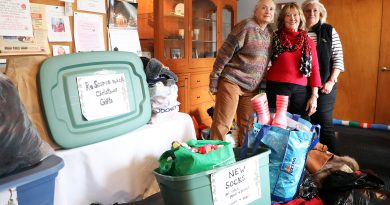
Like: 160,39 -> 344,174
163,0 -> 186,59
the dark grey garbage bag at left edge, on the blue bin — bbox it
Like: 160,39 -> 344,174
0,73 -> 54,177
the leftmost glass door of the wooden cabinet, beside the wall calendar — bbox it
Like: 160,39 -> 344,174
137,0 -> 155,58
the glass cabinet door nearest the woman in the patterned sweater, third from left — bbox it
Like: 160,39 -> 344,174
191,0 -> 217,59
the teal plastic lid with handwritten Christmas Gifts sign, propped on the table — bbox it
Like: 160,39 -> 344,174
39,51 -> 152,148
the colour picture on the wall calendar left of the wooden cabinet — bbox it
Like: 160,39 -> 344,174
108,0 -> 138,30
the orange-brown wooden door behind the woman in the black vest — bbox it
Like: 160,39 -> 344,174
321,0 -> 382,123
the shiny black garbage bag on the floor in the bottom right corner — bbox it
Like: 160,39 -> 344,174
320,171 -> 390,205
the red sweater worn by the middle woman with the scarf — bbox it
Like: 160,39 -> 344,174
267,30 -> 322,87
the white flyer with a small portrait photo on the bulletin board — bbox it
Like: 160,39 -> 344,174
46,5 -> 72,42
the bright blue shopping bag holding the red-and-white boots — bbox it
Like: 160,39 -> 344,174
240,113 -> 320,204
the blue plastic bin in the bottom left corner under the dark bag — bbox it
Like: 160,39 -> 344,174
0,155 -> 64,205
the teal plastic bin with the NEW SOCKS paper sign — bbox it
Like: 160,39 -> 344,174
154,149 -> 271,205
